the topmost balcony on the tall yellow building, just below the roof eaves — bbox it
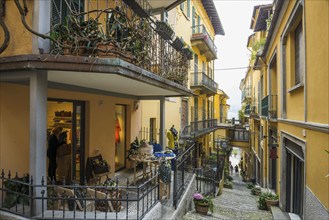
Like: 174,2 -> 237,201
191,25 -> 217,61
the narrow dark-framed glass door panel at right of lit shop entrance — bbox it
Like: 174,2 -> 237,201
71,101 -> 85,184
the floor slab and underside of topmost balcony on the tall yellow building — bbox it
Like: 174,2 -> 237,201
191,33 -> 217,61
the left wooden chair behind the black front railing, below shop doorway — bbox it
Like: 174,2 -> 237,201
55,186 -> 94,211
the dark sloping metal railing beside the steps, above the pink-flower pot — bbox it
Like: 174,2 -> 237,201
173,143 -> 196,209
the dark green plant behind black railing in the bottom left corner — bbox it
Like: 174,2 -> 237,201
3,174 -> 30,209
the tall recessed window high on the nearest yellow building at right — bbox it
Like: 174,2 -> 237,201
295,22 -> 304,85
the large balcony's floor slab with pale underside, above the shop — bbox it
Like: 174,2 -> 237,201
0,55 -> 193,99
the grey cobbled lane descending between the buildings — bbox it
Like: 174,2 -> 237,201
183,174 -> 273,220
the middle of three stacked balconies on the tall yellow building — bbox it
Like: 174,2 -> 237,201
190,72 -> 218,95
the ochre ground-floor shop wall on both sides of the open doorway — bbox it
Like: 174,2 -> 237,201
0,83 -> 141,175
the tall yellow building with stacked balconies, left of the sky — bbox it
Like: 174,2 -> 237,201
141,0 -> 227,162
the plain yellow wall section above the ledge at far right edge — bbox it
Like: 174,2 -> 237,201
305,1 -> 329,124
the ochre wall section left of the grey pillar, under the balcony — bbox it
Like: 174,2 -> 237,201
0,83 -> 30,176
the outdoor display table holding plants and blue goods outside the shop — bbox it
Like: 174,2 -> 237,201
129,155 -> 176,185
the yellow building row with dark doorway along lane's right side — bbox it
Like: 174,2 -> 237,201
244,1 -> 329,219
